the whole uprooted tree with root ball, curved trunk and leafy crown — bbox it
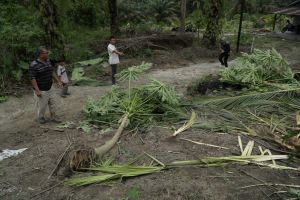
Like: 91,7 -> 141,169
64,63 -> 184,170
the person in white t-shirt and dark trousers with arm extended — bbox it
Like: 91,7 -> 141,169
107,36 -> 124,85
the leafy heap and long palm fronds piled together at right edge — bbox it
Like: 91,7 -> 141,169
193,49 -> 300,149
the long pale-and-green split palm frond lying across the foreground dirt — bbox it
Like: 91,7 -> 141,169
65,137 -> 300,186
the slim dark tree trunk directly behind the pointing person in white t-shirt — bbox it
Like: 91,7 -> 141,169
107,0 -> 120,35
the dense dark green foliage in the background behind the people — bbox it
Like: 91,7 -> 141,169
0,0 -> 291,94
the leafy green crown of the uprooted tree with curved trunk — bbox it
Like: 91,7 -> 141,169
83,63 -> 180,131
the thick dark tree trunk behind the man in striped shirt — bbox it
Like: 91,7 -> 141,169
39,0 -> 64,55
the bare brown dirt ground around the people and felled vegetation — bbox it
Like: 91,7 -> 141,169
0,36 -> 300,200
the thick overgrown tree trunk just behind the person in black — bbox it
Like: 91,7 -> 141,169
202,0 -> 224,48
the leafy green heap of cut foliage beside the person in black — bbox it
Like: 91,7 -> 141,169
219,49 -> 297,87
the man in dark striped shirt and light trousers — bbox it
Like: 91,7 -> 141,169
29,48 -> 62,124
